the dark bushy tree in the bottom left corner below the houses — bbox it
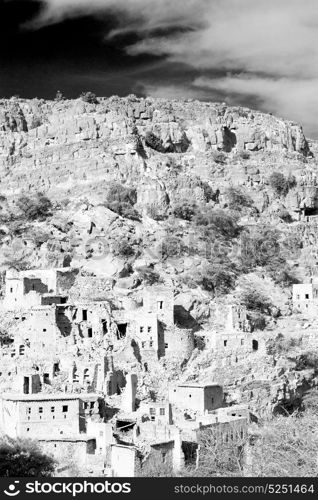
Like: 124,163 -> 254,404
0,437 -> 55,477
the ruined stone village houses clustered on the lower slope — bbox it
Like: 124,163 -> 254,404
0,268 -> 274,477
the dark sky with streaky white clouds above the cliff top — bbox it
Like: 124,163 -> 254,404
0,0 -> 318,138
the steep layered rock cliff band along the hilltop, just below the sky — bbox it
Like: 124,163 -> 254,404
0,97 -> 309,203
